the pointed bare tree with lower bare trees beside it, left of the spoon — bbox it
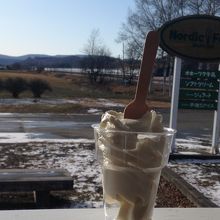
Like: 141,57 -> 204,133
81,29 -> 140,84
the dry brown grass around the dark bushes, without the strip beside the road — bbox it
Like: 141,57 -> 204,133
0,71 -> 170,107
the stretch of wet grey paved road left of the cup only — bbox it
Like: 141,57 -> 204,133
0,113 -> 100,139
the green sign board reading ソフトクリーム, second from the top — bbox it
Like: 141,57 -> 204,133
180,79 -> 219,90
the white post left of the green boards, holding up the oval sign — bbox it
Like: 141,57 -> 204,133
170,57 -> 182,152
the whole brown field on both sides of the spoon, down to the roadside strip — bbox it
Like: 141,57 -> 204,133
0,71 -> 170,113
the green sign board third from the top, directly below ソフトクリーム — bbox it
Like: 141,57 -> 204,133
179,89 -> 218,101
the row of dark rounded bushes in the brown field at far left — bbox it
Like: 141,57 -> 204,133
0,77 -> 52,98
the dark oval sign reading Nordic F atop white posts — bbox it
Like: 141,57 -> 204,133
159,15 -> 220,61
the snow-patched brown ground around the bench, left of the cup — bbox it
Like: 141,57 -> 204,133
0,142 -> 103,208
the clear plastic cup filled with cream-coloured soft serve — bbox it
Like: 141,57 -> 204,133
93,124 -> 175,220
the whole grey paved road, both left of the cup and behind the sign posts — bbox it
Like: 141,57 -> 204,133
0,110 -> 217,142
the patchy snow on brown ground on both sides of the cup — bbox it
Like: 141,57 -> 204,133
0,134 -> 220,208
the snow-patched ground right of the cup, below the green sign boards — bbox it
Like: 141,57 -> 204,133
169,136 -> 220,206
